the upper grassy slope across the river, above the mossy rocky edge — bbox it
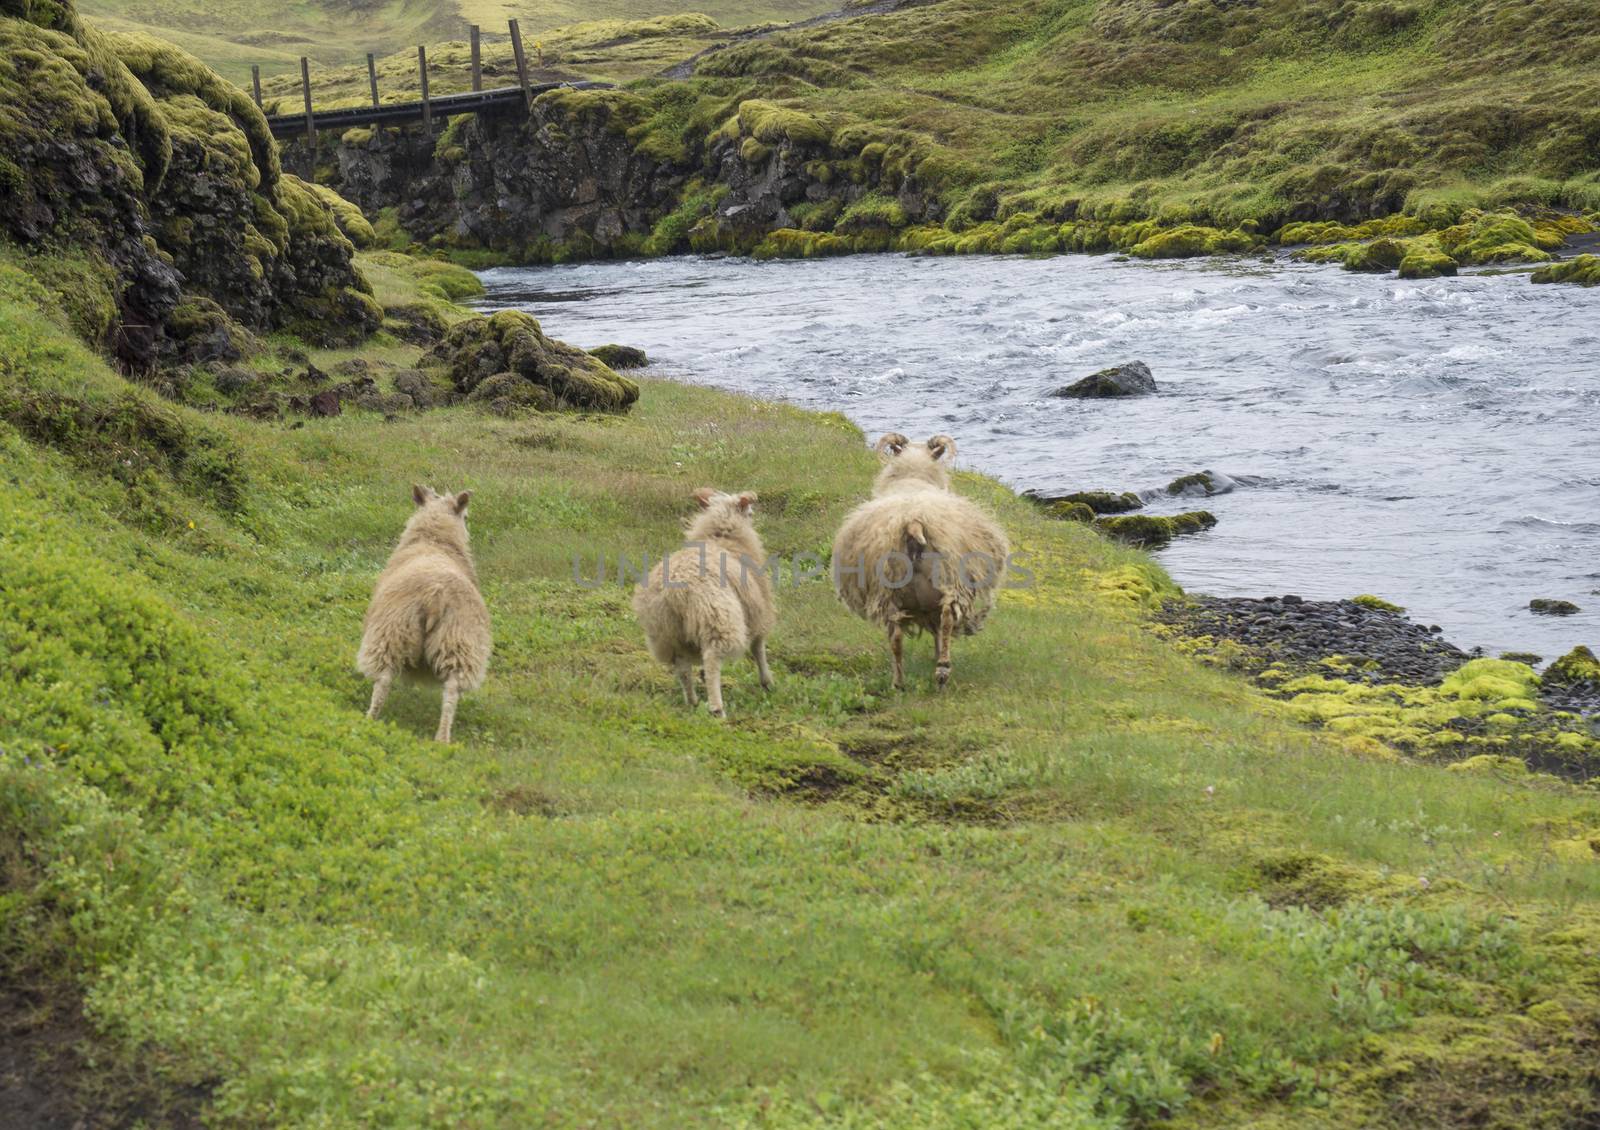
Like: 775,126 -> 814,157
678,0 -> 1600,224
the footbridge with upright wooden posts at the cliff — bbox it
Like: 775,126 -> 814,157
259,19 -> 611,144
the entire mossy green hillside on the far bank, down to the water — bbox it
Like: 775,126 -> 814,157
288,0 -> 1600,274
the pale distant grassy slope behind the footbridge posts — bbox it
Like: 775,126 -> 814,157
78,0 -> 837,85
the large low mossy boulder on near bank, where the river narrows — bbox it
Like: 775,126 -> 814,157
424,311 -> 638,411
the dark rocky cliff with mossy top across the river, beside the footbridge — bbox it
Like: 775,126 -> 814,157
315,91 -> 941,261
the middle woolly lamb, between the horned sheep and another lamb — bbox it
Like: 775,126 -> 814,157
634,487 -> 778,719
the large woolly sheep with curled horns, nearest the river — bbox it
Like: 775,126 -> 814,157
834,432 -> 1010,690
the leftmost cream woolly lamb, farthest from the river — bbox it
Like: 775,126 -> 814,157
355,487 -> 491,743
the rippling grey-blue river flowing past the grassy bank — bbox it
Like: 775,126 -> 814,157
483,256 -> 1600,658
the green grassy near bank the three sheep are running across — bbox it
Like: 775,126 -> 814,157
9,251 -> 1600,1127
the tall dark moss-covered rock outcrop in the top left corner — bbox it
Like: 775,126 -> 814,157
0,0 -> 381,370
